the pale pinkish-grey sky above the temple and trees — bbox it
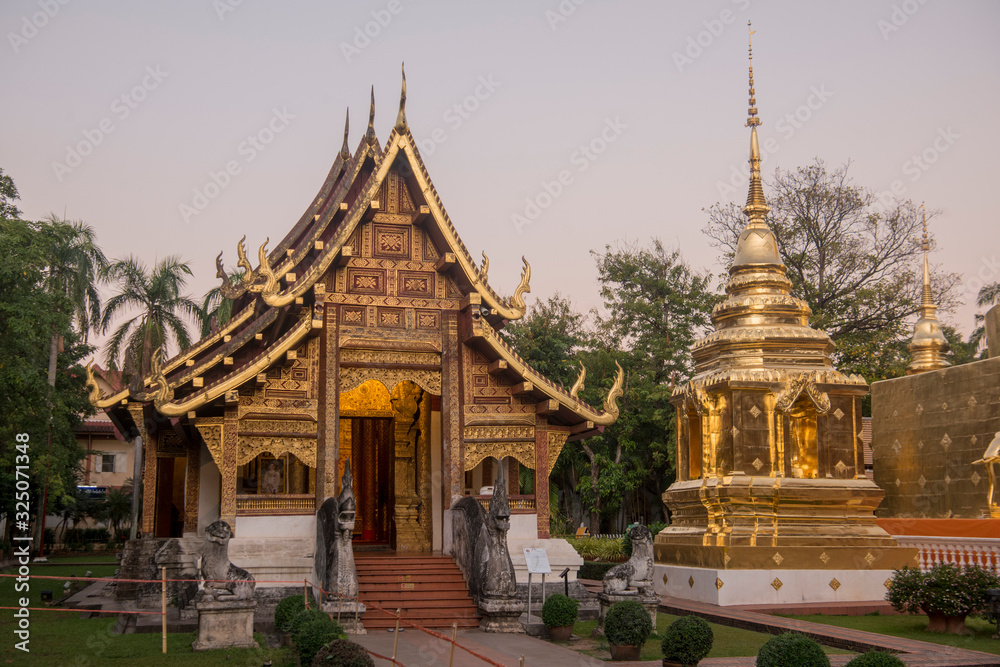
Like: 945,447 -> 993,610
0,0 -> 1000,358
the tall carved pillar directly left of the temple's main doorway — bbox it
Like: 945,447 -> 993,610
310,294 -> 340,510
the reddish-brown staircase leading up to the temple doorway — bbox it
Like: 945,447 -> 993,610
354,551 -> 479,632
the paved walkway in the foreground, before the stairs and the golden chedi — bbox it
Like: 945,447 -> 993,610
356,598 -> 1000,667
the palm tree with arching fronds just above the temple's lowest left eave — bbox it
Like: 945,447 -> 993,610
101,255 -> 200,377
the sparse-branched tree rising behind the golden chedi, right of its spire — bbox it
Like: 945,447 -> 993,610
704,159 -> 958,382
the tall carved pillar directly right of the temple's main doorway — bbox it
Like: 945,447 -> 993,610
441,311 -> 464,508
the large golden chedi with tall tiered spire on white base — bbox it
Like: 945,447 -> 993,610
654,34 -> 915,605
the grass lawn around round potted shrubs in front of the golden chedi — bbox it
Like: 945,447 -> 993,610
558,612 -> 853,660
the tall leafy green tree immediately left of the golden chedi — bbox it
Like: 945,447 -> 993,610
582,239 -> 720,532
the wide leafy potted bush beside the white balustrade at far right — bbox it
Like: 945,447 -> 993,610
885,563 -> 1000,635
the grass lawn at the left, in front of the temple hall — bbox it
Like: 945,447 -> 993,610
0,556 -> 297,667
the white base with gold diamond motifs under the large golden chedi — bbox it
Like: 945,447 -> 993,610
653,565 -> 892,606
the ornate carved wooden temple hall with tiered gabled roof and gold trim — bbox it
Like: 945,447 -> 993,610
91,69 -> 622,579
